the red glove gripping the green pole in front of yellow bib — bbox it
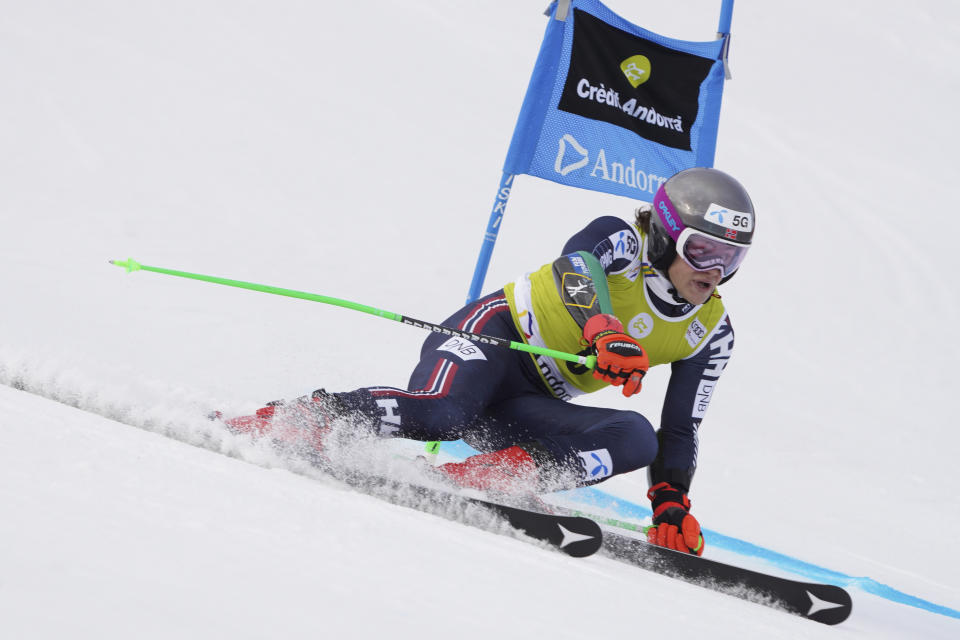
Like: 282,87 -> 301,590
583,313 -> 650,398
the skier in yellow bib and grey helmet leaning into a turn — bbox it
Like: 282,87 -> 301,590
227,168 -> 756,555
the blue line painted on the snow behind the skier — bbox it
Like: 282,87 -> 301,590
441,440 -> 960,619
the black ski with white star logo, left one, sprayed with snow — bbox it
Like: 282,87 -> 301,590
328,469 -> 603,558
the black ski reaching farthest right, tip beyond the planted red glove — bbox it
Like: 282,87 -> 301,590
601,530 -> 853,625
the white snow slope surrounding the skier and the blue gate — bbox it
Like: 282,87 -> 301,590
0,0 -> 960,639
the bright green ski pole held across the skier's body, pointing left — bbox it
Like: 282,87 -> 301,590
110,258 -> 597,369
